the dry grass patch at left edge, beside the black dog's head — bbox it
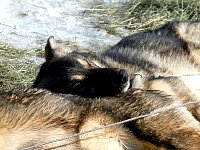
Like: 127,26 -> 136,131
0,43 -> 42,90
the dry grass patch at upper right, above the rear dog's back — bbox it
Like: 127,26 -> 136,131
88,0 -> 200,34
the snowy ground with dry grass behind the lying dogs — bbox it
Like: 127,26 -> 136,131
0,0 -> 200,90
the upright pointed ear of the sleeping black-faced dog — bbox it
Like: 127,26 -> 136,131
45,36 -> 65,61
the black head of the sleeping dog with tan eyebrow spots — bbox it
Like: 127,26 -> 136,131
33,37 -> 130,97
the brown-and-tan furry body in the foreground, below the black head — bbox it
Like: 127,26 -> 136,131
0,89 -> 200,150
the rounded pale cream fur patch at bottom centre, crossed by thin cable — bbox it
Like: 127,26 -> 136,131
80,114 -> 140,150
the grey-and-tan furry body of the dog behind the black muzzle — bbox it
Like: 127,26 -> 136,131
103,21 -> 200,121
